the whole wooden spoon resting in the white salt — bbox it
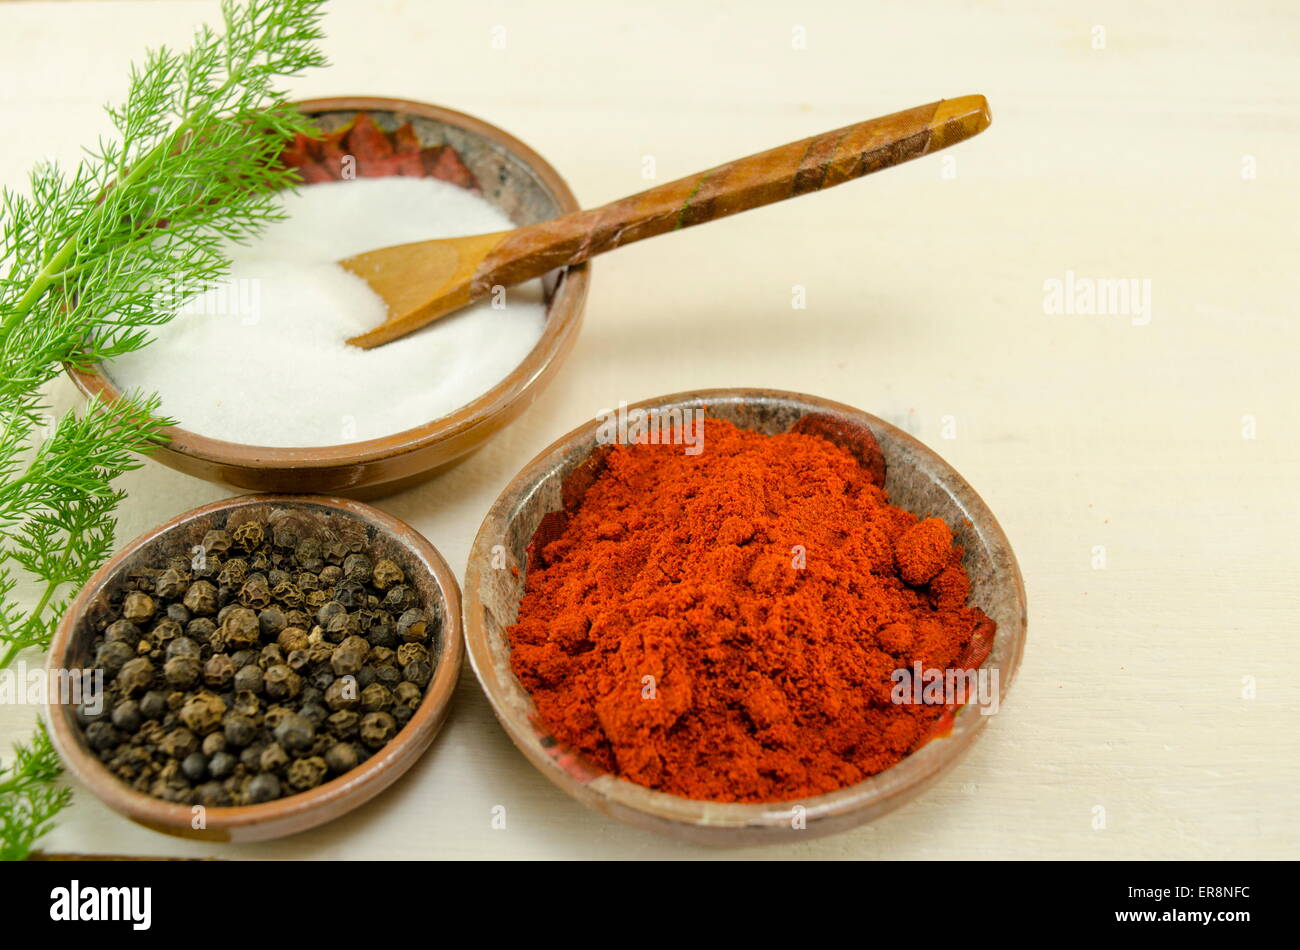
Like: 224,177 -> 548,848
339,96 -> 991,350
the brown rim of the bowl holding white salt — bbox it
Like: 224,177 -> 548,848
65,96 -> 592,473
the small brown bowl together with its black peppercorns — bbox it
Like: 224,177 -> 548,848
48,495 -> 462,841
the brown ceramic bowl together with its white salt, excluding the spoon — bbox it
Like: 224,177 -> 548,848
68,97 -> 590,498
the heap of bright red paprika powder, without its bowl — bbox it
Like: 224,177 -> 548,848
508,418 -> 993,802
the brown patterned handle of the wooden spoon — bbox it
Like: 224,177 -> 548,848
471,96 -> 991,298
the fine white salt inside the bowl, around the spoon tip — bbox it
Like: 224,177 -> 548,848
107,178 -> 546,447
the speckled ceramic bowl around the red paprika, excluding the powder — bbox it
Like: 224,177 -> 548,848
464,389 -> 1026,845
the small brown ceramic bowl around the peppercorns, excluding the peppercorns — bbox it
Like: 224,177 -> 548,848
47,495 -> 462,841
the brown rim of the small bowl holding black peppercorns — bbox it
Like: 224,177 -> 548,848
46,493 -> 464,840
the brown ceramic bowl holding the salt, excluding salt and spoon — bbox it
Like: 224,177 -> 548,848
68,97 -> 590,498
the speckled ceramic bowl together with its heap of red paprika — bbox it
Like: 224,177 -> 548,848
464,389 -> 1026,845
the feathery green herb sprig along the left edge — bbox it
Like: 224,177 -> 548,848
0,0 -> 325,858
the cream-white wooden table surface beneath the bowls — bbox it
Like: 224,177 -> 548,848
0,0 -> 1300,859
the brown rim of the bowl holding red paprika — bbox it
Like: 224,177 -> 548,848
463,387 -> 1028,845
